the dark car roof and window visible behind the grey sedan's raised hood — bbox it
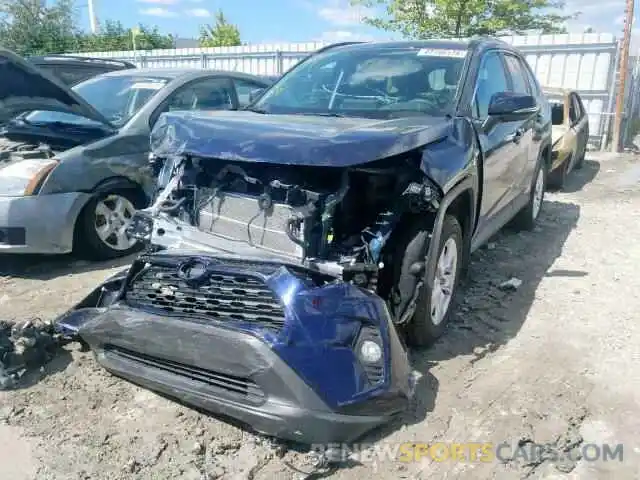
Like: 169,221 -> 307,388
27,55 -> 136,86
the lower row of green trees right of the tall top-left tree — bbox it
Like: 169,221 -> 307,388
79,20 -> 174,52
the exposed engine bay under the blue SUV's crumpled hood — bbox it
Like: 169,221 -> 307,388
131,156 -> 440,302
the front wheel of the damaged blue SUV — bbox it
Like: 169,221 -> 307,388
402,215 -> 463,347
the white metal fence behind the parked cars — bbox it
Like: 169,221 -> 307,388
71,34 -> 631,146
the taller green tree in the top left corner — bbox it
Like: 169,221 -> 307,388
0,0 -> 78,55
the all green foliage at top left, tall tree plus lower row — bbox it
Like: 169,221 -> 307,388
0,0 -> 174,56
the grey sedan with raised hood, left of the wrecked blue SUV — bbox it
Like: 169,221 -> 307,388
0,51 -> 268,258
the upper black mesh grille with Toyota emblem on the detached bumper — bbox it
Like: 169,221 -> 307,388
125,265 -> 284,332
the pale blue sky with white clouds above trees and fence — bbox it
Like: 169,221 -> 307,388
77,0 -> 640,43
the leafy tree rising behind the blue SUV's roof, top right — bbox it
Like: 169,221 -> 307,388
351,0 -> 575,39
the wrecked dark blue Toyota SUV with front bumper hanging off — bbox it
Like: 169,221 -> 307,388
58,39 -> 551,443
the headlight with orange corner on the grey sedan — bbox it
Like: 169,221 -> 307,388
0,159 -> 59,197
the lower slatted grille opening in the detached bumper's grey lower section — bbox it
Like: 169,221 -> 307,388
105,345 -> 266,403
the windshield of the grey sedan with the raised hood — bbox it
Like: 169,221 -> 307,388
23,75 -> 168,127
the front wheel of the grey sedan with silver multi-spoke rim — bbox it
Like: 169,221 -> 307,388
75,189 -> 142,260
